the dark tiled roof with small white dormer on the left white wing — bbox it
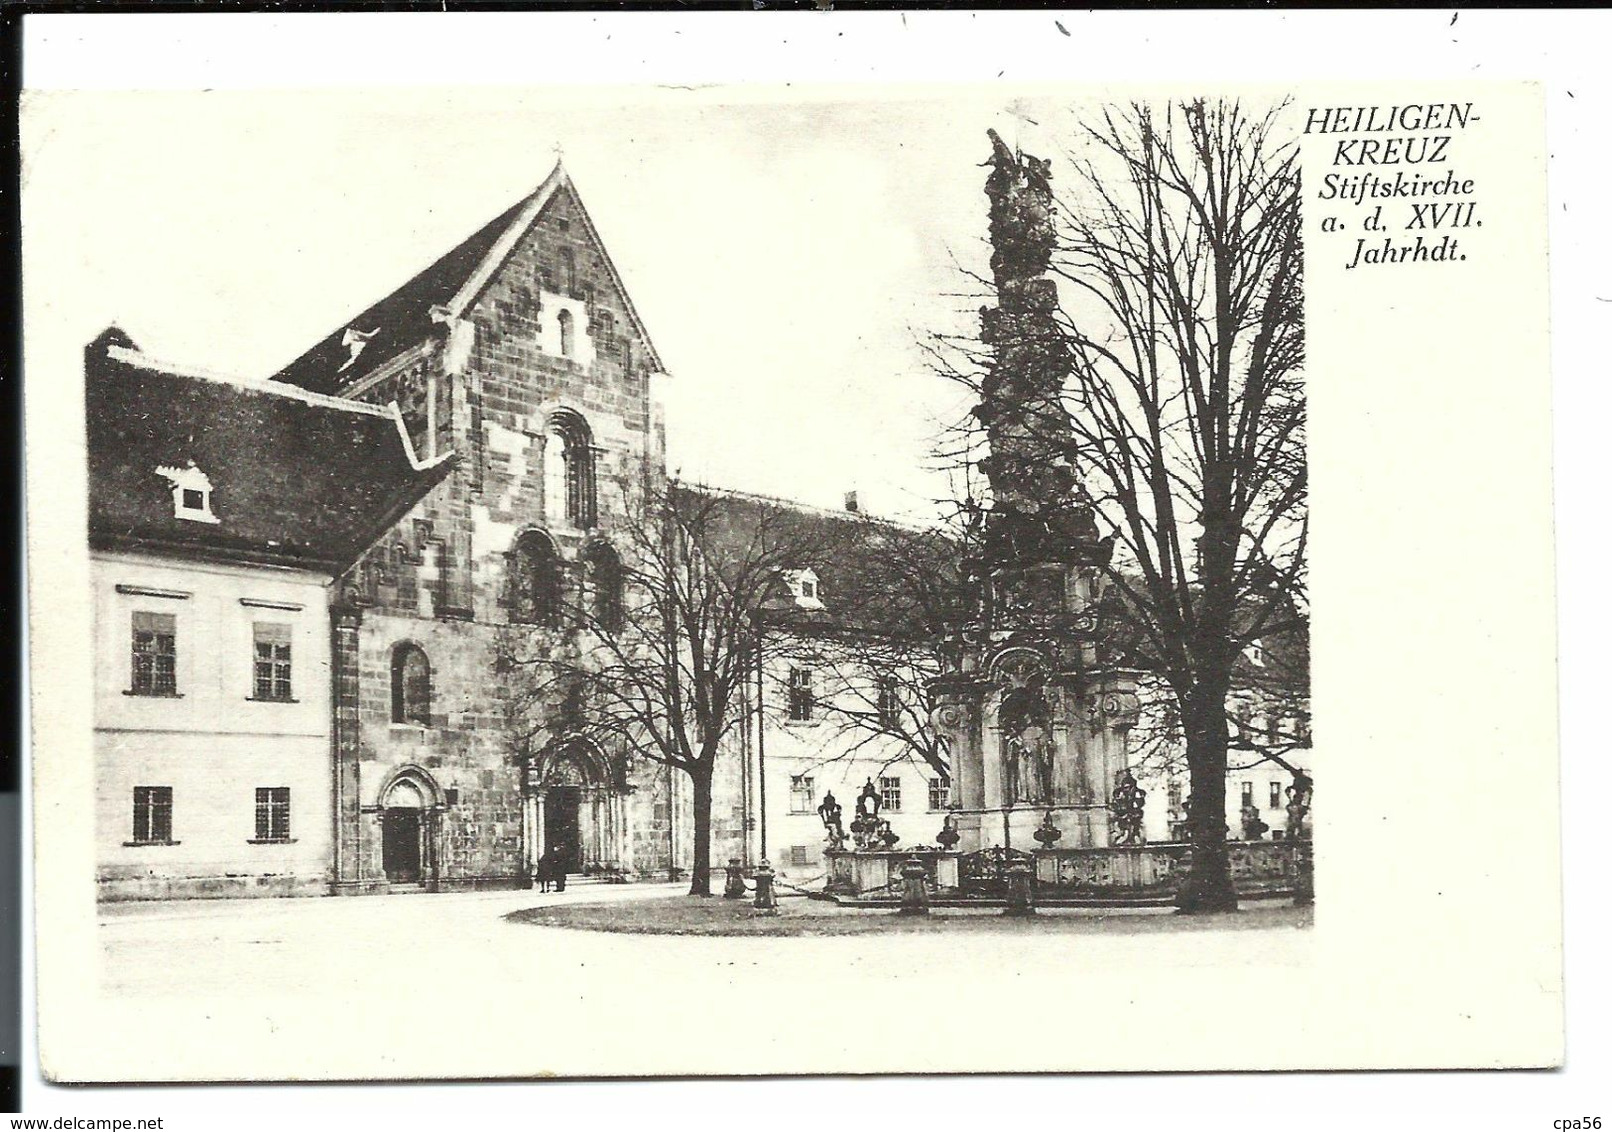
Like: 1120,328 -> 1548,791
84,331 -> 453,574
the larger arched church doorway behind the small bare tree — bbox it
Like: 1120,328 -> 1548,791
522,739 -> 630,877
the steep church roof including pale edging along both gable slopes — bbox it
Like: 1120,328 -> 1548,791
274,163 -> 661,393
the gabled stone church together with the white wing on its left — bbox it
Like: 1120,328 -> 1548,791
85,164 -> 745,898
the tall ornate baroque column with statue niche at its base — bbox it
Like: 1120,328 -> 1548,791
932,132 -> 1138,851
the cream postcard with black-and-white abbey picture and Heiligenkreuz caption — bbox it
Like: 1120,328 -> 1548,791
23,8 -> 1560,1109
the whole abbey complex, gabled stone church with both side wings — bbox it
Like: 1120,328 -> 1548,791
84,153 -> 1307,900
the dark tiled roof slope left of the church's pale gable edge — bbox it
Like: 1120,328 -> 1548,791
274,197 -> 530,393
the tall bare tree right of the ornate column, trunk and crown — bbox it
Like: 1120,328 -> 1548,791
949,100 -> 1307,911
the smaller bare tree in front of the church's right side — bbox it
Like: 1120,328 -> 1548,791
501,477 -> 809,897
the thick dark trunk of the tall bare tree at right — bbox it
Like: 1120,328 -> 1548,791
1175,684 -> 1236,913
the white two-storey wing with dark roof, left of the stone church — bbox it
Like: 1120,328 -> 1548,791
85,331 -> 451,898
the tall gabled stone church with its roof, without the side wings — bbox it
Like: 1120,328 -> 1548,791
276,166 -> 742,892
